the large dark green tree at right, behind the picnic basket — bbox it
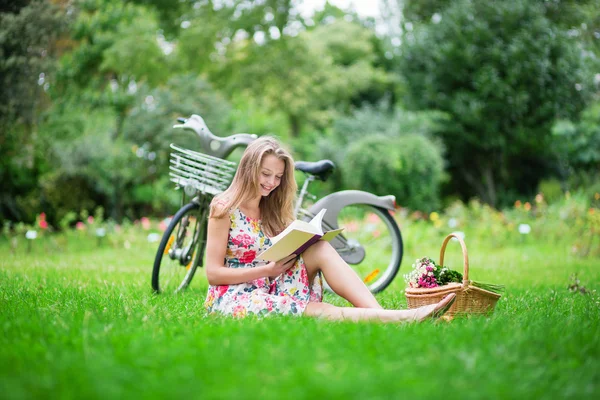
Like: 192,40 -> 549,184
399,0 -> 589,205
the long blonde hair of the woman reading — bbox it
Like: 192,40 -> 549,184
210,136 -> 298,236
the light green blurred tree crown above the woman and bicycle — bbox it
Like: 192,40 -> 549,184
209,20 -> 390,138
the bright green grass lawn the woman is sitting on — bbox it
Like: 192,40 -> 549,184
0,224 -> 600,399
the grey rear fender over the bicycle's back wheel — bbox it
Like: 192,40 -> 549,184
309,190 -> 396,228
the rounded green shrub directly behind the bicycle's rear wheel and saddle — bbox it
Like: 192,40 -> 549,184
342,135 -> 443,211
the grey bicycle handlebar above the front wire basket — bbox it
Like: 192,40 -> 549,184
173,114 -> 258,158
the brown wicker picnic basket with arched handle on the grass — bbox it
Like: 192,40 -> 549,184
405,233 -> 500,318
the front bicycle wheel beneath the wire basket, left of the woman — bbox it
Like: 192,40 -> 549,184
152,203 -> 206,293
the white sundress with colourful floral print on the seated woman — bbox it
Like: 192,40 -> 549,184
204,209 -> 323,317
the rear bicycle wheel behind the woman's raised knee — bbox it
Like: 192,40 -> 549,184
324,204 -> 404,293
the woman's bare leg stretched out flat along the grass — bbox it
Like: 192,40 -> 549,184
304,294 -> 456,322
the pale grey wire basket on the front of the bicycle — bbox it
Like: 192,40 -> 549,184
169,144 -> 236,195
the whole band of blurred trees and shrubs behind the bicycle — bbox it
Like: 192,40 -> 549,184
0,0 -> 600,226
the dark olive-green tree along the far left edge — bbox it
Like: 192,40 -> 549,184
0,0 -> 67,222
